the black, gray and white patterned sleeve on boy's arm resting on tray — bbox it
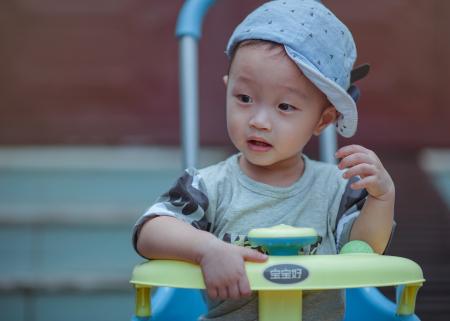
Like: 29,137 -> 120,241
132,168 -> 212,253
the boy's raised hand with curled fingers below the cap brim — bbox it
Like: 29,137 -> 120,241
336,145 -> 395,201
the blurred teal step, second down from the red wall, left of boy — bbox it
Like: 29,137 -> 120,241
0,224 -> 142,291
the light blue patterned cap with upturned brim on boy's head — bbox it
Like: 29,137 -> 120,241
226,0 -> 358,137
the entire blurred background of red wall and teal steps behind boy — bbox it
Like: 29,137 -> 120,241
0,0 -> 450,321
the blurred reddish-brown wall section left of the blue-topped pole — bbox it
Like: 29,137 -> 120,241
0,0 -> 181,144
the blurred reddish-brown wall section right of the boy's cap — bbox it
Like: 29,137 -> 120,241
328,0 -> 450,147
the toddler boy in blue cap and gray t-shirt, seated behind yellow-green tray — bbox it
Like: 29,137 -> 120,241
133,0 -> 395,321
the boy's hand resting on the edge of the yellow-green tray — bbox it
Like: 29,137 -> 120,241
199,239 -> 267,300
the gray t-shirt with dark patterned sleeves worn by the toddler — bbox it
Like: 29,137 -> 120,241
133,154 -> 367,321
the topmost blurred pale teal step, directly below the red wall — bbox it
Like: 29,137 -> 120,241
0,147 -> 230,224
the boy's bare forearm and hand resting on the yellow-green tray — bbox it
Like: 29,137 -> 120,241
137,216 -> 267,300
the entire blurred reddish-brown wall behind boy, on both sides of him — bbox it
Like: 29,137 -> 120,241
0,0 -> 450,147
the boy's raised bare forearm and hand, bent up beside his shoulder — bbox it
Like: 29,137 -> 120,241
336,145 -> 395,254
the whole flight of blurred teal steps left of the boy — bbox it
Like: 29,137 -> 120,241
0,147 -> 230,321
